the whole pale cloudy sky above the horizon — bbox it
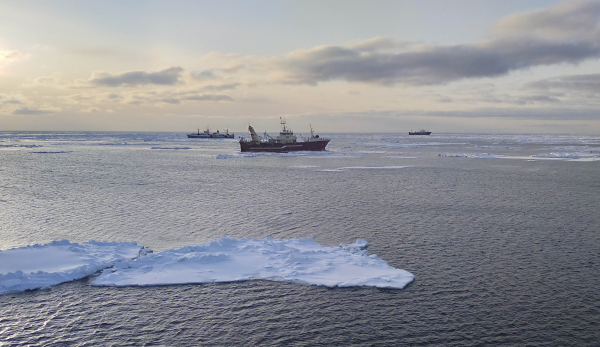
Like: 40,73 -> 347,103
0,0 -> 600,134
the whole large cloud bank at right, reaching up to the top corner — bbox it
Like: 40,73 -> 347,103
266,2 -> 600,85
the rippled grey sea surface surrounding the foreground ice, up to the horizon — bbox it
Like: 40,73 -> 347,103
0,132 -> 600,346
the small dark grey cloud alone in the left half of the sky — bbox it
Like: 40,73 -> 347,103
89,66 -> 183,87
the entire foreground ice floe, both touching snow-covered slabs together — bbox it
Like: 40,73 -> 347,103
0,238 -> 414,294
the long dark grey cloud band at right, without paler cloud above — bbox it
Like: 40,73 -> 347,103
276,38 -> 600,85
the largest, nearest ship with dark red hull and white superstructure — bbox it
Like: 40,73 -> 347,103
240,118 -> 330,152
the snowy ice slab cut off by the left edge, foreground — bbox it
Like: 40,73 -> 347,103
0,240 -> 142,294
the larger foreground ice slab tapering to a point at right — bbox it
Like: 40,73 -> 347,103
91,238 -> 414,289
